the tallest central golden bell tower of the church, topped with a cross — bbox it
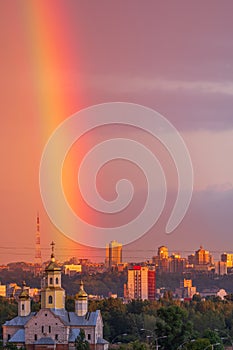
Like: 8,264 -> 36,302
41,242 -> 65,309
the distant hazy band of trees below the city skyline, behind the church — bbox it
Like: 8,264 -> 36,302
3,269 -> 233,297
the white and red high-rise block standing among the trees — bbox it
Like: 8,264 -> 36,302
125,266 -> 156,300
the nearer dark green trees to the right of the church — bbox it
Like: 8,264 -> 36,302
89,293 -> 233,350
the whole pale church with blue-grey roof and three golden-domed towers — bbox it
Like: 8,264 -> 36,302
3,246 -> 108,350
